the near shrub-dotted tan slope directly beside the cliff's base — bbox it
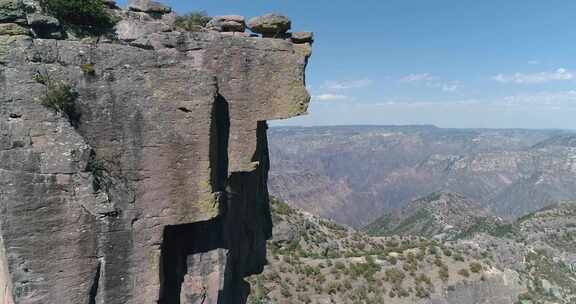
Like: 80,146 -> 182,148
249,200 -> 527,304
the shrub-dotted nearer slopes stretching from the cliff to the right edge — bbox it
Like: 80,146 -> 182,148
249,194 -> 576,304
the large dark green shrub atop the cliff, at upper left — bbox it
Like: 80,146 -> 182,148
40,0 -> 117,35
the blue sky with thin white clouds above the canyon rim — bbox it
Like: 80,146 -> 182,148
119,0 -> 576,129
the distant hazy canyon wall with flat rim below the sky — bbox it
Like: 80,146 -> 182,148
270,126 -> 576,228
